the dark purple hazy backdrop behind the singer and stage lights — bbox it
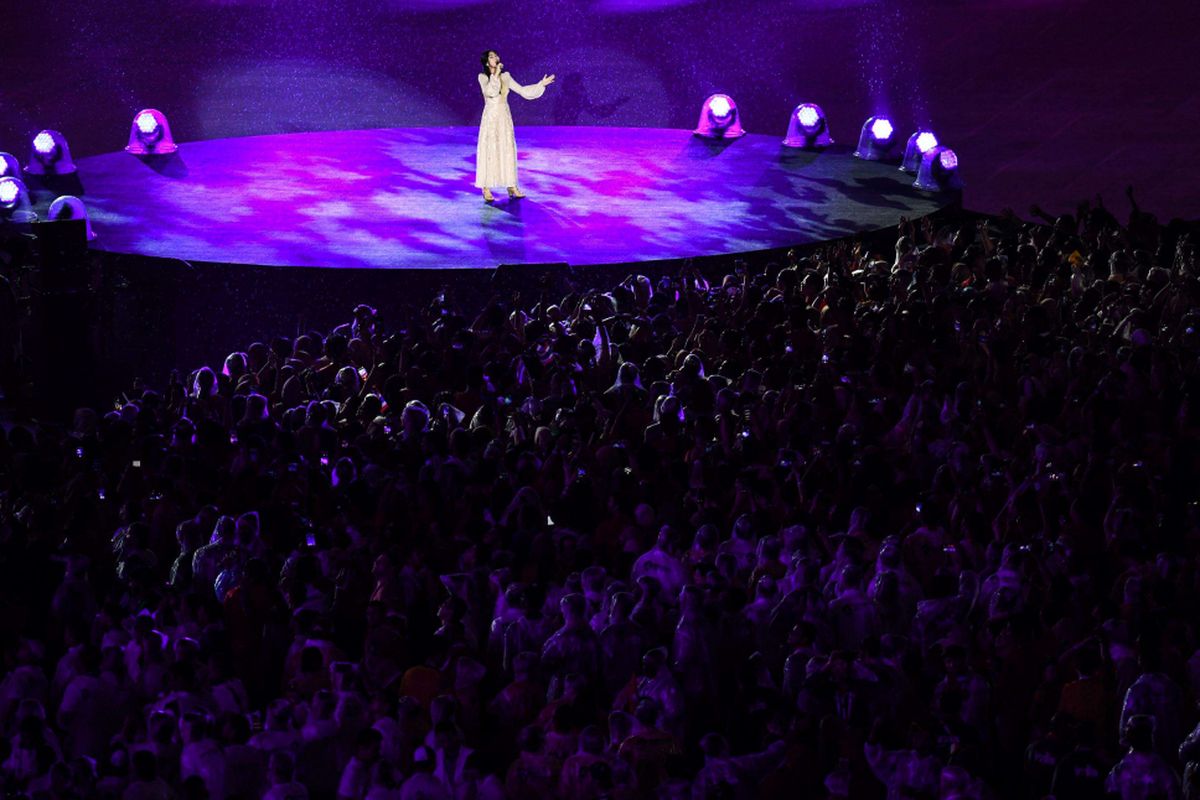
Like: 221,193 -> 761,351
0,0 -> 1200,217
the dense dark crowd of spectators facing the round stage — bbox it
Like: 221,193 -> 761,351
0,189 -> 1200,800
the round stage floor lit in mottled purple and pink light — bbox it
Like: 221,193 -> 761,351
79,127 -> 958,269
